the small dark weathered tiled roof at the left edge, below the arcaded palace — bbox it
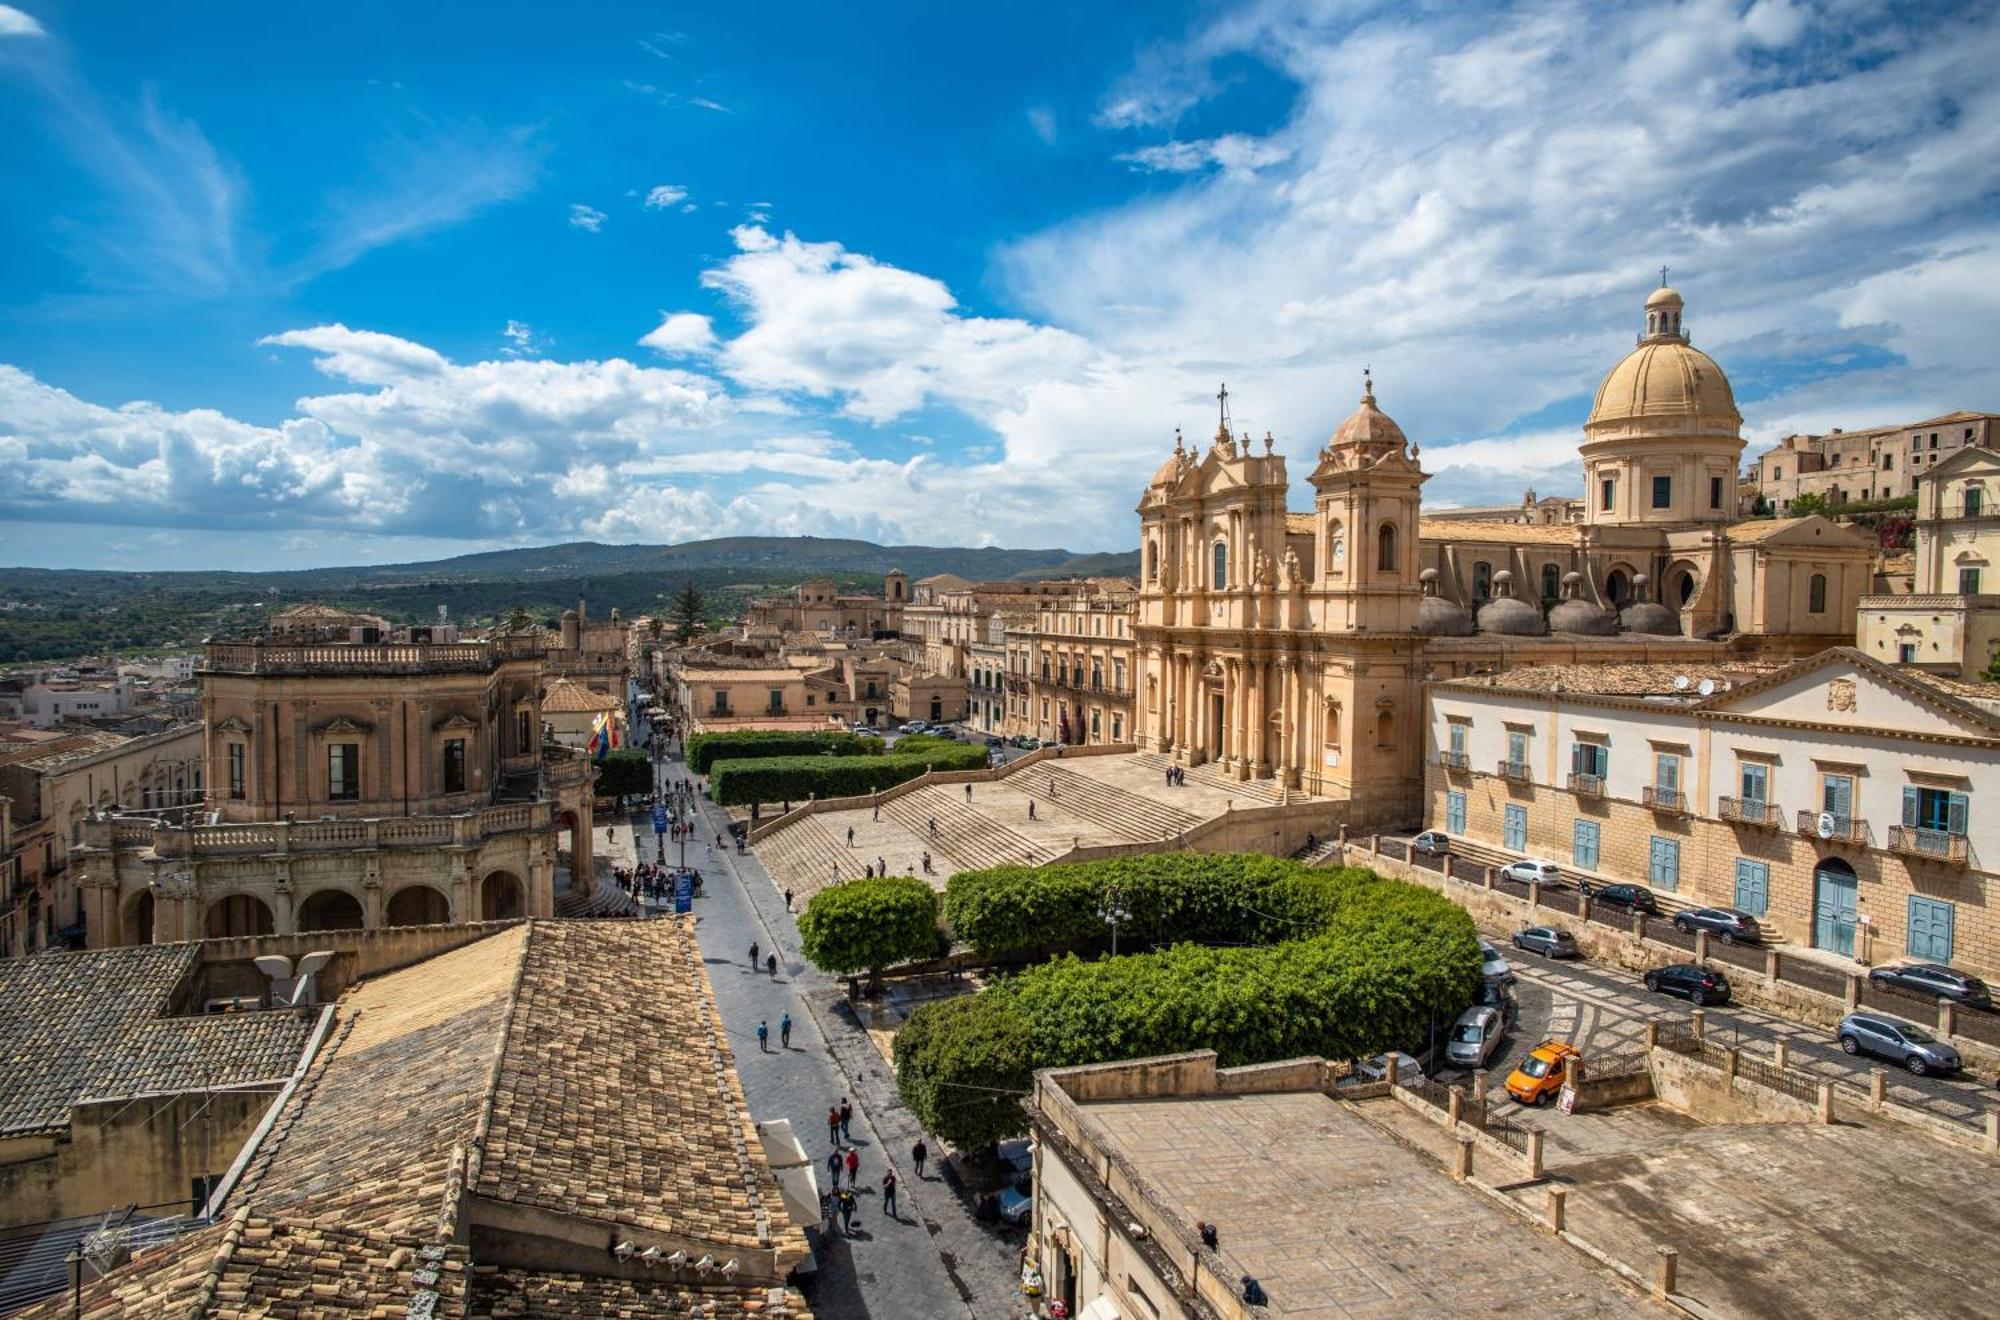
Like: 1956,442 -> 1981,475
0,944 -> 312,1136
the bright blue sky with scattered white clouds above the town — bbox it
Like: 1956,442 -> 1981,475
0,0 -> 2000,568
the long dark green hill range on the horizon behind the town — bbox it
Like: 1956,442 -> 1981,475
0,536 -> 1138,662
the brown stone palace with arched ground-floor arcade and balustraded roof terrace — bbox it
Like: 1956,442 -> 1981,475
72,634 -> 592,948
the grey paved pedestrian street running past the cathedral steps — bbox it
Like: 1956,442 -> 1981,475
656,762 -> 1032,1320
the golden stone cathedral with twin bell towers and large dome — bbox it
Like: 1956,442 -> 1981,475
1134,288 -> 1874,824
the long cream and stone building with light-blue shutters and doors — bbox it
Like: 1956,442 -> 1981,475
1424,648 -> 2000,974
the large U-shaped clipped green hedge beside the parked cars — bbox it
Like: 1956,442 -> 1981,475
896,854 -> 1480,1148
